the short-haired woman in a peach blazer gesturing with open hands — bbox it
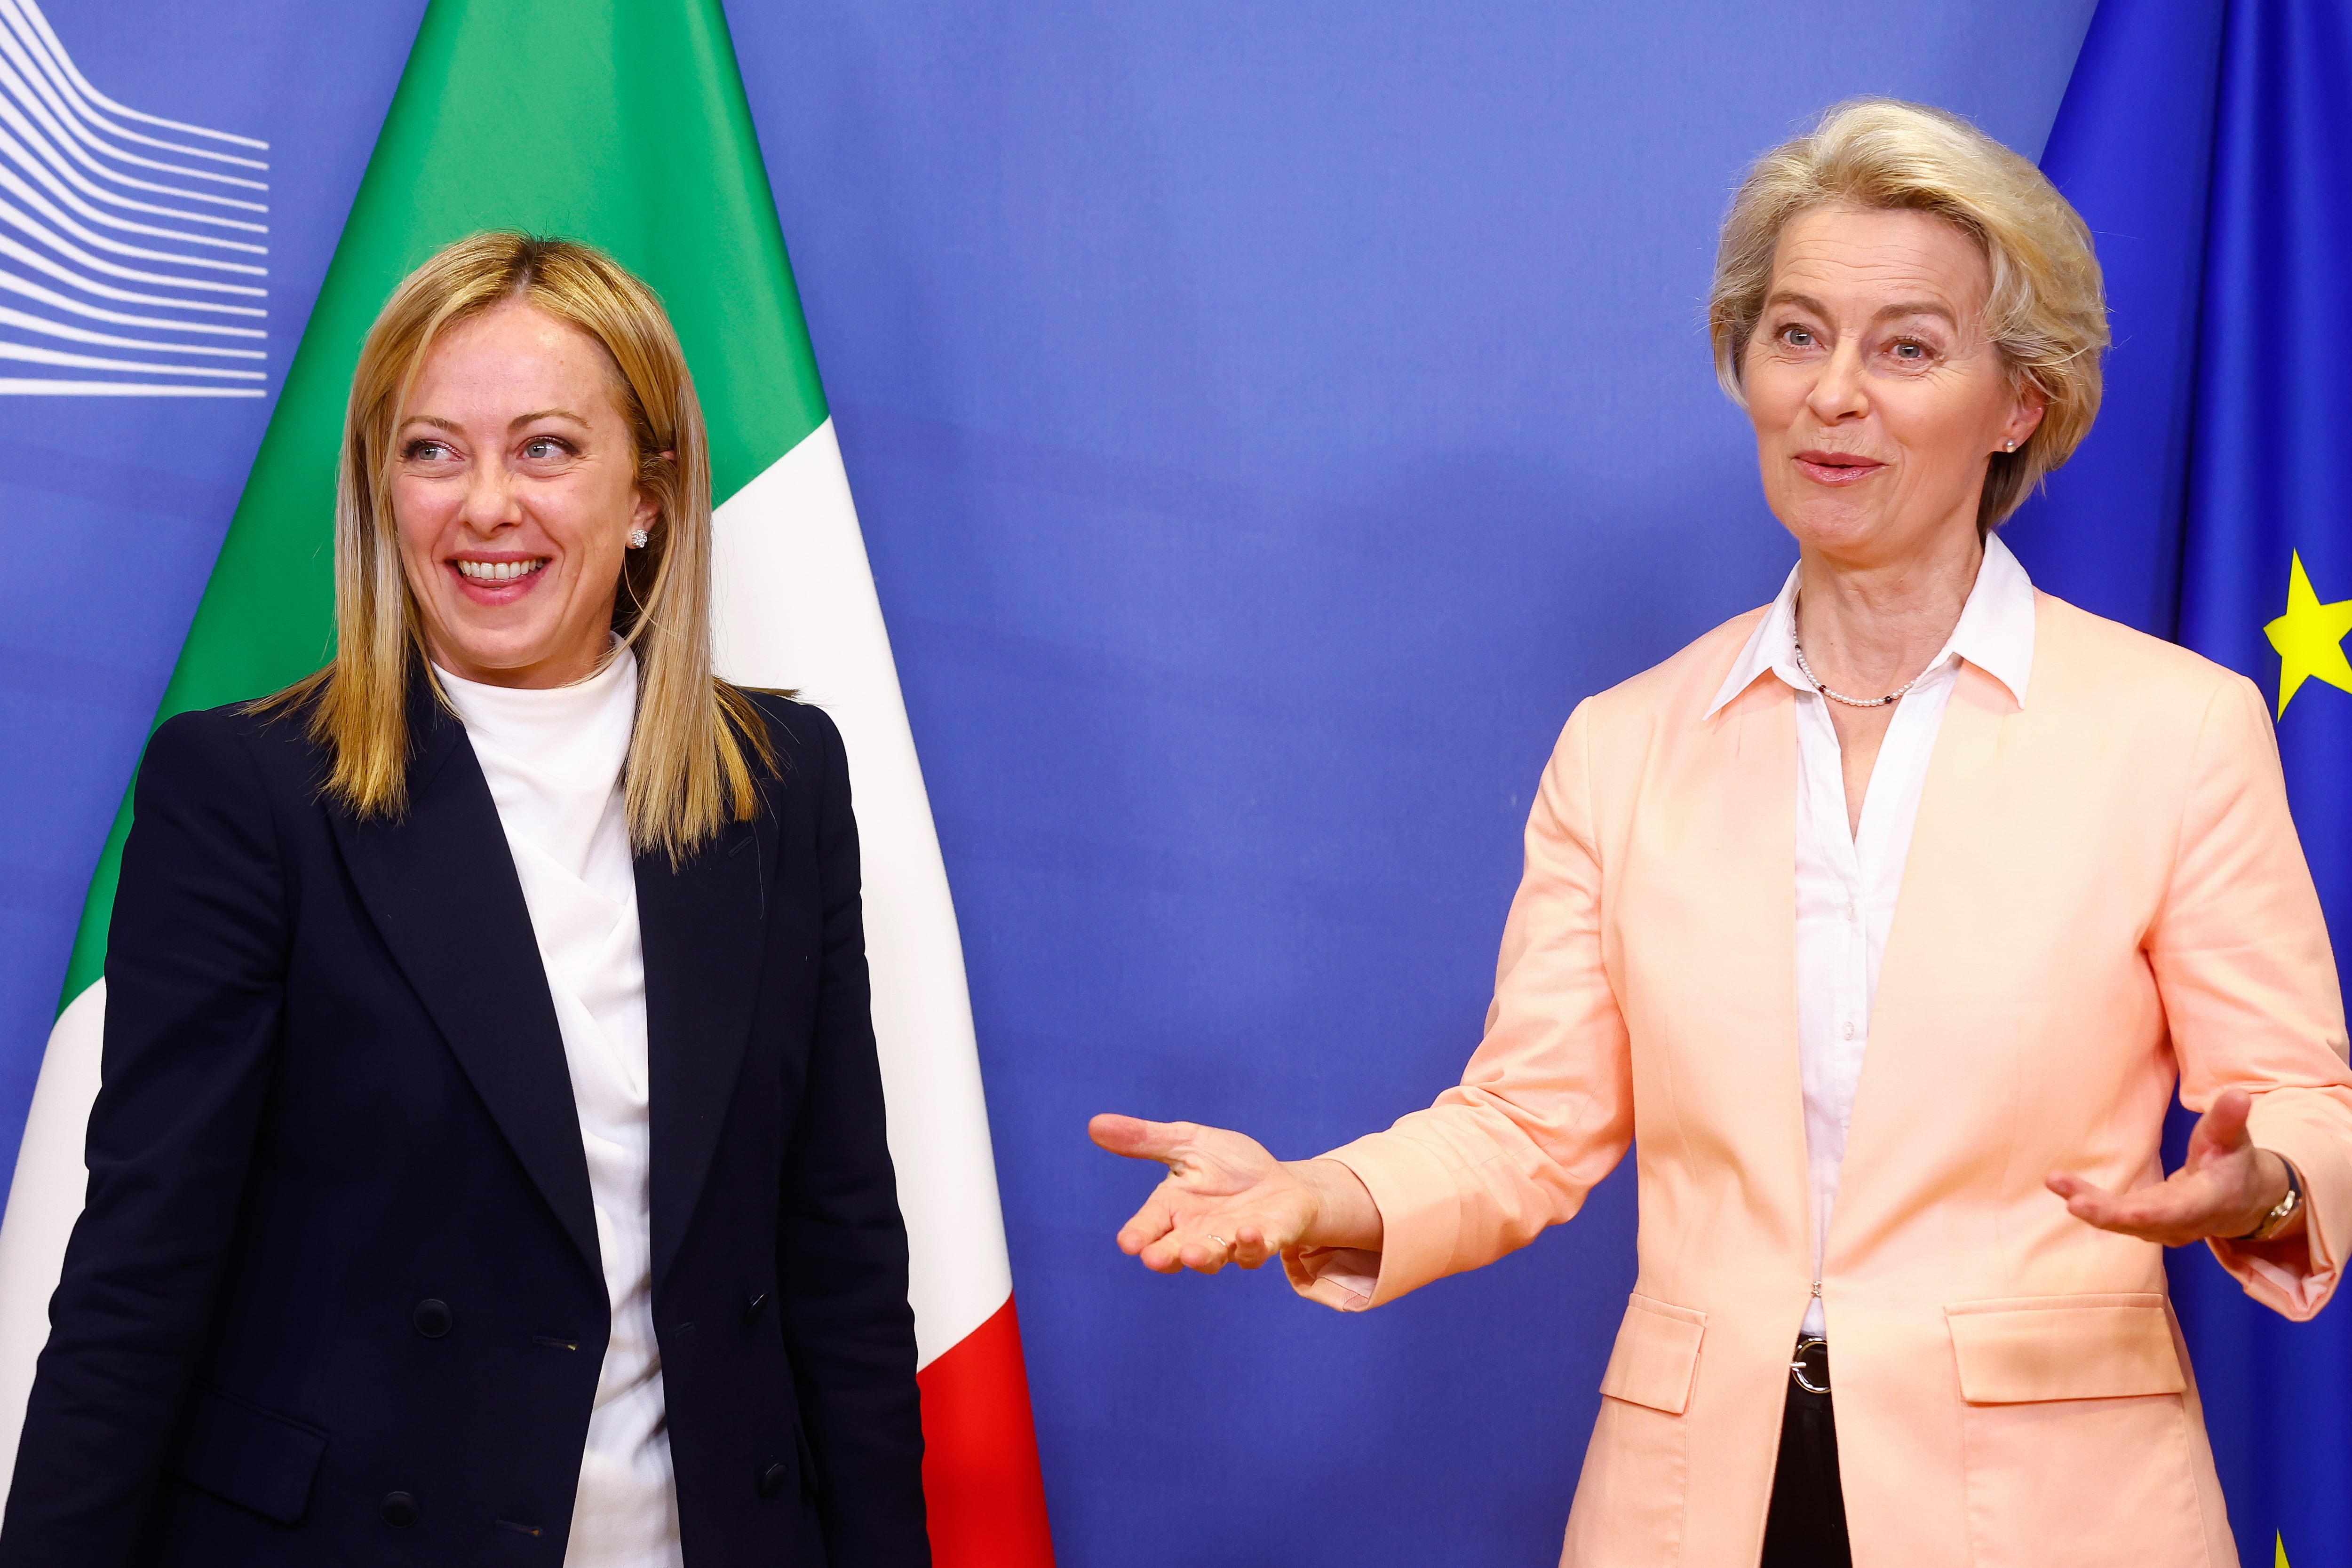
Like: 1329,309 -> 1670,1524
1094,101 -> 2352,1568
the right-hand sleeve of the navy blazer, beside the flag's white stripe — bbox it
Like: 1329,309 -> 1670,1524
776,708 -> 931,1568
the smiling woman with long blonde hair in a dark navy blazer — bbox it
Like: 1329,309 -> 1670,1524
0,235 -> 929,1568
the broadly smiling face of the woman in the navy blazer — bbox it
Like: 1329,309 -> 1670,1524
390,301 -> 659,687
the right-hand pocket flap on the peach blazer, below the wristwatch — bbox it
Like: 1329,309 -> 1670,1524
1943,1293 -> 2187,1406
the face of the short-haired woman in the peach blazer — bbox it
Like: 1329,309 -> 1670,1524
1743,207 -> 2042,569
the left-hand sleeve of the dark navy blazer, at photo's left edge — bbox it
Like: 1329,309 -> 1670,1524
0,713 -> 287,1568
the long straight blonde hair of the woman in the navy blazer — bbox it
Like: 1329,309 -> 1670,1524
261,230 -> 774,863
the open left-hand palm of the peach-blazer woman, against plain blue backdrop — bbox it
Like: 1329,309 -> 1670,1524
1087,1117 -> 1381,1274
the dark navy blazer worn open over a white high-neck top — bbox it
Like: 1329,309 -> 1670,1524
0,687 -> 929,1568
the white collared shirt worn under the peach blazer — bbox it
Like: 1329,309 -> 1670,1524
1708,534 -> 2034,1335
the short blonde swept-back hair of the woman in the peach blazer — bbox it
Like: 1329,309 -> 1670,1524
1708,99 -> 2107,529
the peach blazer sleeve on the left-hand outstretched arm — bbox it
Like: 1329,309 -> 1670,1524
1284,703 -> 1632,1312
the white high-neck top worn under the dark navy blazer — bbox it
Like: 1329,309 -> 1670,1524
440,649 -> 684,1568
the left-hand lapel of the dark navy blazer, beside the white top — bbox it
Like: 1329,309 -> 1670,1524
329,680 -> 602,1279
